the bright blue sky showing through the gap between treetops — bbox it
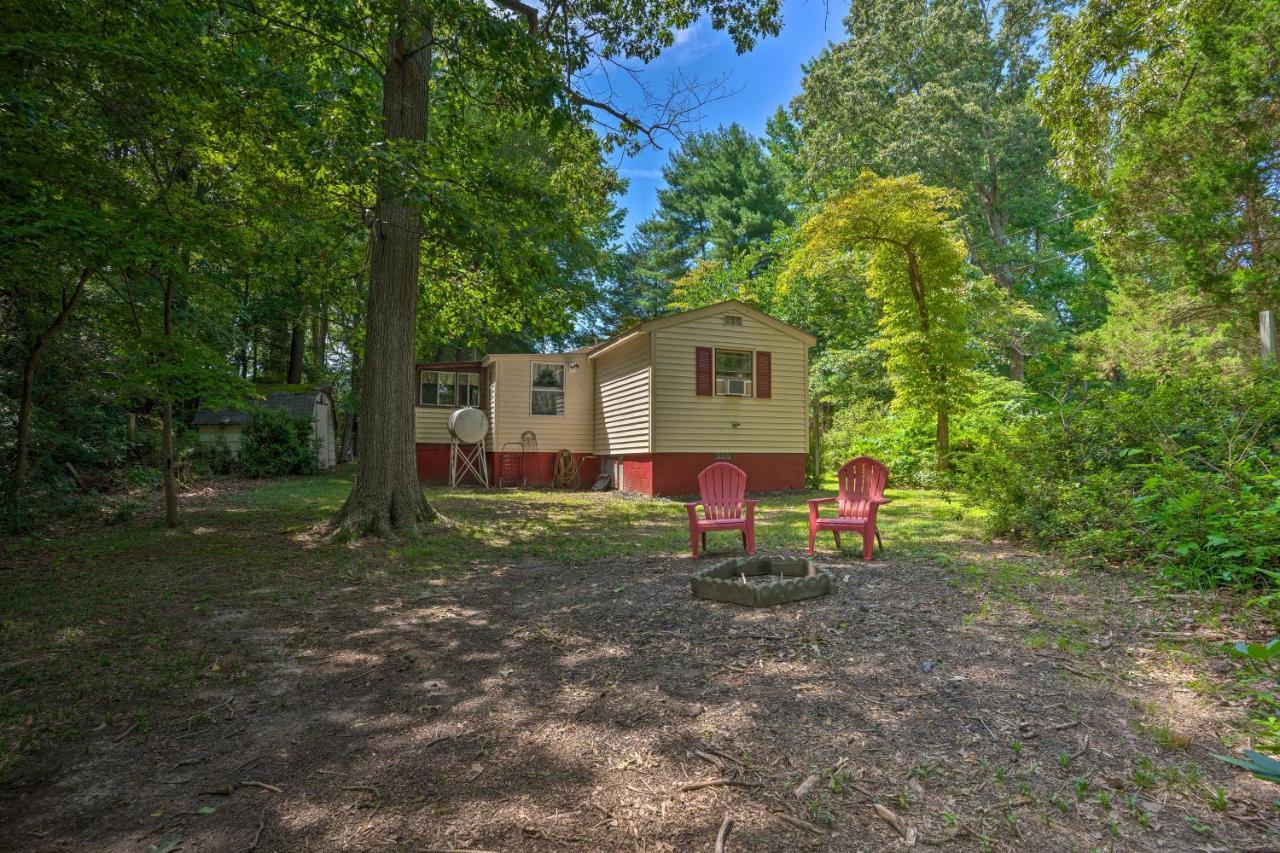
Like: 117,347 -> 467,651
612,0 -> 849,238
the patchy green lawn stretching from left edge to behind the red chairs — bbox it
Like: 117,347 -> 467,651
0,473 -> 977,777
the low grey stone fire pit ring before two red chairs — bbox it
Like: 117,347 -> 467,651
690,557 -> 836,607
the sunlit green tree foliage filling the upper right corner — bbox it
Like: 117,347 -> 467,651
1037,0 -> 1280,311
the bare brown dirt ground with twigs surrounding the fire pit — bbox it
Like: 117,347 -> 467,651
0,481 -> 1280,853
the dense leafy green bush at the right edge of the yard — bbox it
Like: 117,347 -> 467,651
961,374 -> 1280,588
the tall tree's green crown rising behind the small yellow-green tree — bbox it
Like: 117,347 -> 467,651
795,0 -> 1105,369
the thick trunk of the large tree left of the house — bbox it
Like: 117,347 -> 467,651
333,6 -> 435,537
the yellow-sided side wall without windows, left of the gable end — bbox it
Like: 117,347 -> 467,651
594,336 -> 650,456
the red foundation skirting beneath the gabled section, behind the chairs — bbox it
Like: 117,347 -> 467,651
621,453 -> 805,496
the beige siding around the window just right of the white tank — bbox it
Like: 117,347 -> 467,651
489,353 -> 595,453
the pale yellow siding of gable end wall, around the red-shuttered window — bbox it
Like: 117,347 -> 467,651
650,307 -> 809,453
